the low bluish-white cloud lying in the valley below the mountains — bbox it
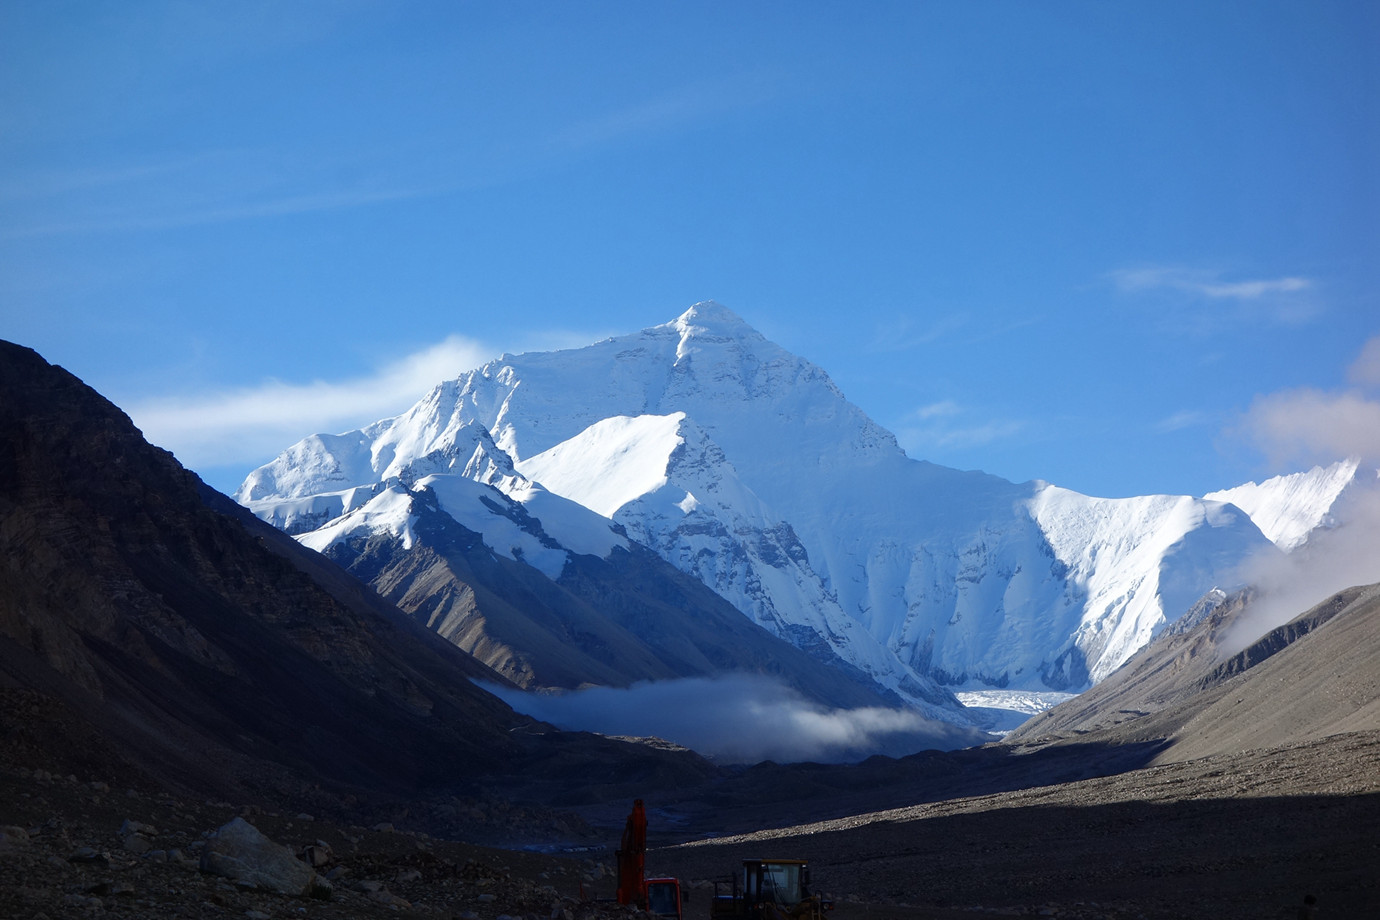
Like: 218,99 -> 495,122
484,674 -> 991,763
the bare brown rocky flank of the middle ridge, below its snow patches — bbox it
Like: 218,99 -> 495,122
301,474 -> 916,710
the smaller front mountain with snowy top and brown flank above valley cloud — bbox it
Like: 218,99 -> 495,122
236,358 -> 932,724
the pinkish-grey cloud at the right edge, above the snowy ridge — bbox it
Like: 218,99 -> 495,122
1231,335 -> 1380,468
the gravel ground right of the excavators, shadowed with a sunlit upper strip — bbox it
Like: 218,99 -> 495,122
647,732 -> 1380,920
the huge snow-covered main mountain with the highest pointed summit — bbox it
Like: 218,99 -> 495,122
236,302 -> 1357,705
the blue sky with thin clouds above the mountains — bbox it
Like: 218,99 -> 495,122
0,0 -> 1380,495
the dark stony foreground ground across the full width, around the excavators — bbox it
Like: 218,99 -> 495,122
0,732 -> 1380,920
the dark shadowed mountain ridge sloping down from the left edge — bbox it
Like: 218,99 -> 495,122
0,343 -> 711,822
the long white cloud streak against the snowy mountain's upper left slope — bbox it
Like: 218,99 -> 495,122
126,335 -> 494,469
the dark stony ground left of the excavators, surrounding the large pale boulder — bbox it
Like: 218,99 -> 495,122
0,768 -> 629,920
